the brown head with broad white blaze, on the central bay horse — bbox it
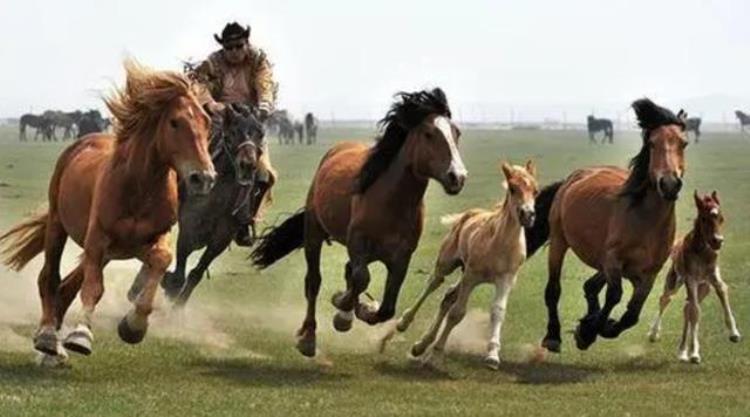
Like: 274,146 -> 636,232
407,114 -> 468,195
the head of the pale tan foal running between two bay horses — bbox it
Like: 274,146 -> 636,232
500,160 -> 539,228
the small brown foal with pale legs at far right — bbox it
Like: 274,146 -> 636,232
649,191 -> 742,363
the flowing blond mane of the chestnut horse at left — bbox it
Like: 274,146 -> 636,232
104,59 -> 204,143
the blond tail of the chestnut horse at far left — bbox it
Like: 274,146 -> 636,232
0,212 -> 49,271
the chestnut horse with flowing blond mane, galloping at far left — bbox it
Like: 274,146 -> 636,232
0,60 -> 216,362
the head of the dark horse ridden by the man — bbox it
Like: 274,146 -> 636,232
217,104 -> 265,185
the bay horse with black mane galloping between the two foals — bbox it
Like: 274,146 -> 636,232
526,98 -> 688,352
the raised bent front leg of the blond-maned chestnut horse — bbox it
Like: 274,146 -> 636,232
117,235 -> 172,344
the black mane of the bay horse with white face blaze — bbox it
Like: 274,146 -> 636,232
356,88 -> 451,193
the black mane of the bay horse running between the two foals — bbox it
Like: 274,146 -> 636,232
620,98 -> 685,204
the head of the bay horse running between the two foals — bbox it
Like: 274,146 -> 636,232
632,99 -> 688,201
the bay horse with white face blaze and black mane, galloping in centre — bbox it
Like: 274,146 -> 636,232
252,88 -> 467,356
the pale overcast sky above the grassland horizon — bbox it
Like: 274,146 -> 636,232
0,0 -> 750,121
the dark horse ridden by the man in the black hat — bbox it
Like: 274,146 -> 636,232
162,104 -> 265,306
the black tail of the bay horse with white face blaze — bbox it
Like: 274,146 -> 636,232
250,210 -> 305,269
